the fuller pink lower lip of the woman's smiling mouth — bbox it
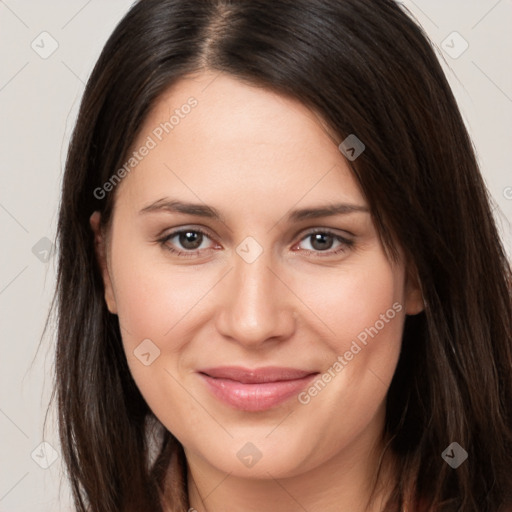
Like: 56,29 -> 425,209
200,373 -> 317,412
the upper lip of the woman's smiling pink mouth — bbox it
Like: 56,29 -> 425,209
199,366 -> 318,384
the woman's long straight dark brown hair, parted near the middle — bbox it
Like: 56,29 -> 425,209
56,0 -> 512,512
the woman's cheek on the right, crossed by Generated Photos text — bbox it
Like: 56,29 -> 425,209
290,251 -> 405,432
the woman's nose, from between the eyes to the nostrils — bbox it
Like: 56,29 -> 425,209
217,248 -> 296,349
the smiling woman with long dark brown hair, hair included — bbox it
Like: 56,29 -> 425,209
53,0 -> 512,512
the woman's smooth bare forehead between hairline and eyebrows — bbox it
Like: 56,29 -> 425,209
115,73 -> 364,214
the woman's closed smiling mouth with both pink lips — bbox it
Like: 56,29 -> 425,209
198,366 -> 319,412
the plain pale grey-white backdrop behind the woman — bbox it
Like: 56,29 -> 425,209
0,0 -> 512,512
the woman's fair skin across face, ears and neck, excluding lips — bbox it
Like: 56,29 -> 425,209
91,72 -> 423,512
